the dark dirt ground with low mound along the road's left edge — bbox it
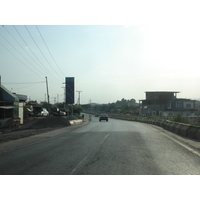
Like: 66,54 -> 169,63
0,116 -> 70,143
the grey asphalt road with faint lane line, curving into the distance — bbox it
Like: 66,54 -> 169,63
0,117 -> 200,175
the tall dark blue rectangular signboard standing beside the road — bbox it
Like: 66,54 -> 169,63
65,77 -> 74,104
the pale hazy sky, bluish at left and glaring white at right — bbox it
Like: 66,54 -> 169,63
0,2 -> 200,104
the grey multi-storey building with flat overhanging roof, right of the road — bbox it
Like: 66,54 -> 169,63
139,91 -> 196,117
